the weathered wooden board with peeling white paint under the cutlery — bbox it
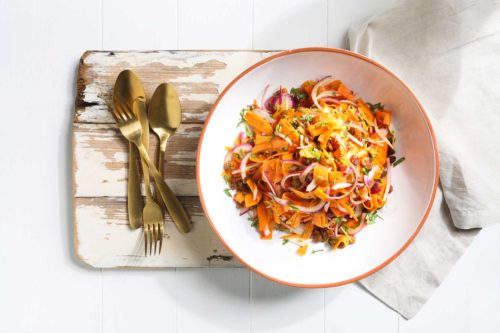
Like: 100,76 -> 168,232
73,51 -> 276,268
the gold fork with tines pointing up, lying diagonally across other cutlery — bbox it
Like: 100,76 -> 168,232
112,99 -> 192,239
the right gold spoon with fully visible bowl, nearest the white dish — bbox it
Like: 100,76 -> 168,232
148,83 -> 182,208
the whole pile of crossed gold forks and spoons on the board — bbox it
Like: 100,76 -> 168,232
112,70 -> 192,255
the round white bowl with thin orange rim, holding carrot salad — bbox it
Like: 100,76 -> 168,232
197,48 -> 438,287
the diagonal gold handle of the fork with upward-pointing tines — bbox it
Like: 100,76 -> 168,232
137,144 -> 193,233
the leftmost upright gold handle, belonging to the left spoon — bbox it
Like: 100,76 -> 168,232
127,143 -> 142,229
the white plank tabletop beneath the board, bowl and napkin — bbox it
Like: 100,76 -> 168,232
0,0 -> 500,333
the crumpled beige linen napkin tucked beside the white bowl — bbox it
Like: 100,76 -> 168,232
348,0 -> 500,318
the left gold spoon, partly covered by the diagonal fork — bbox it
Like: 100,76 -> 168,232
113,70 -> 146,229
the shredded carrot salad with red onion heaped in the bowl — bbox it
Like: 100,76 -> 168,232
222,79 -> 394,255
